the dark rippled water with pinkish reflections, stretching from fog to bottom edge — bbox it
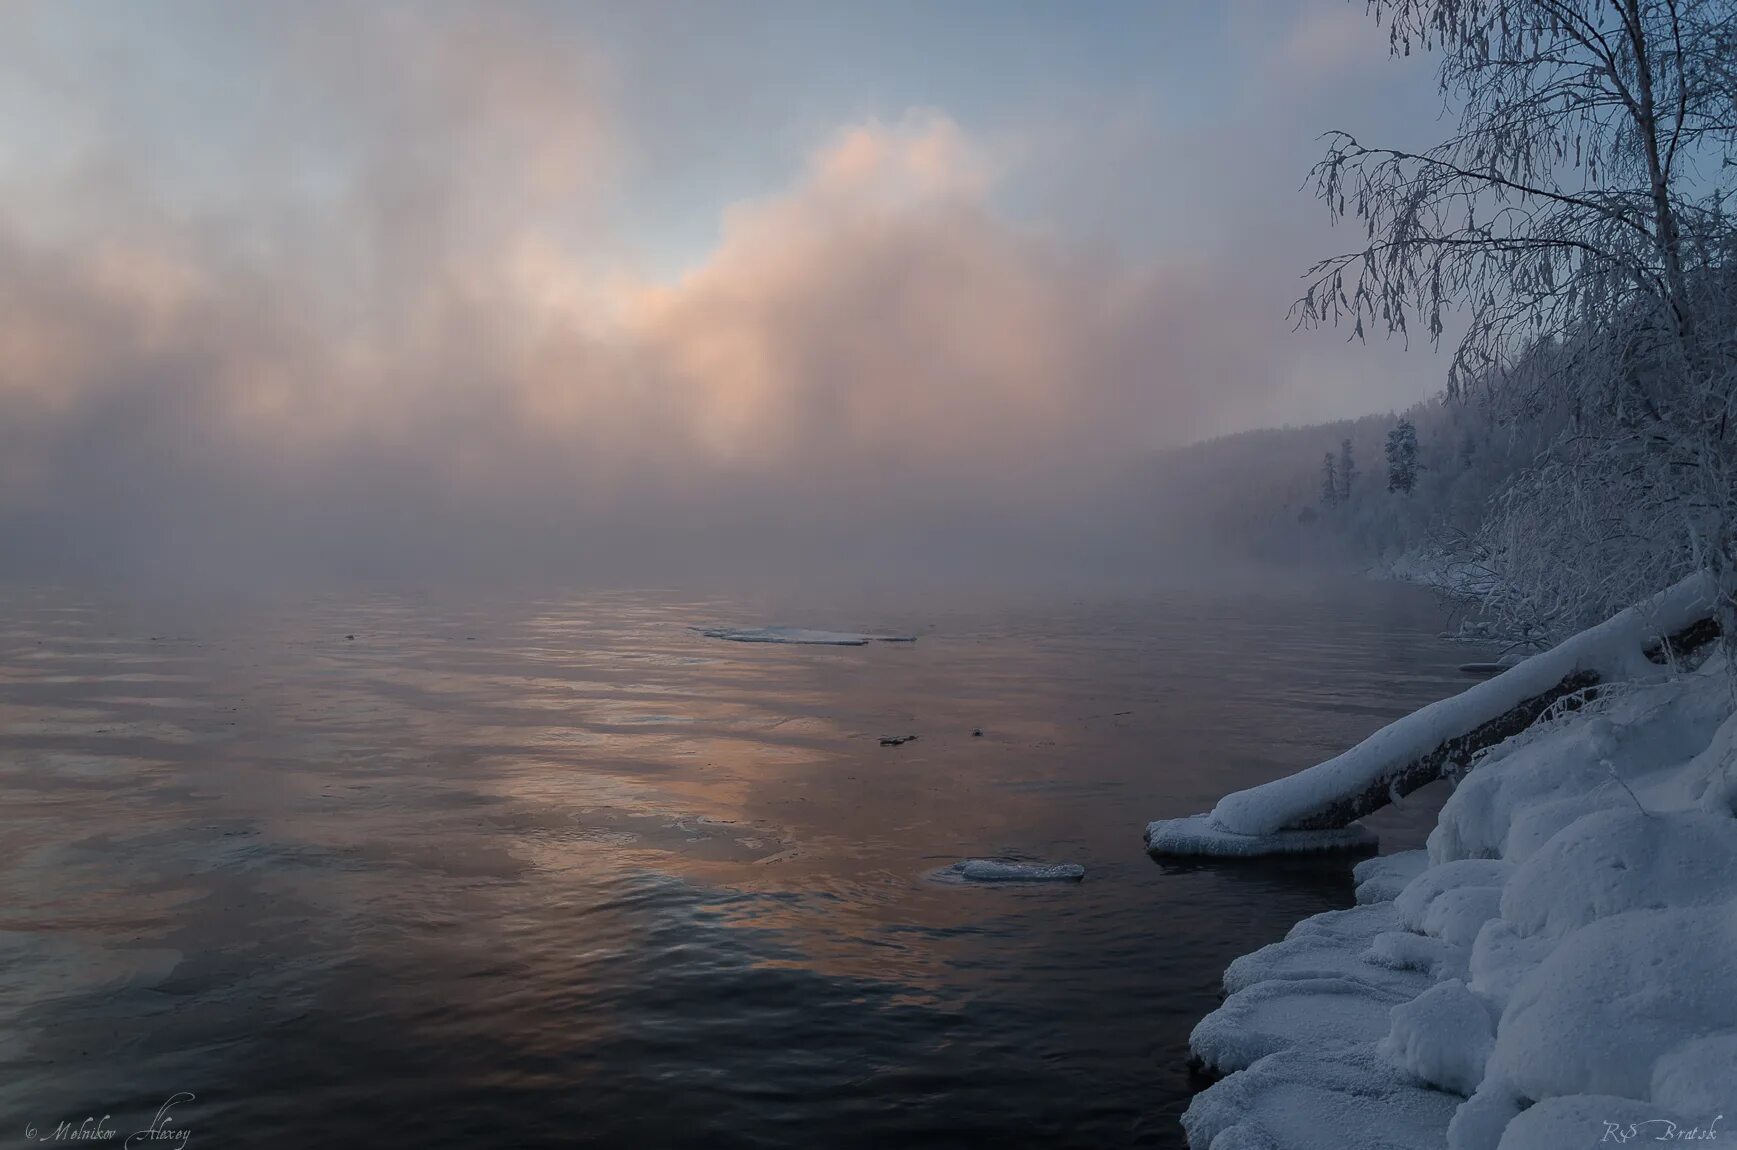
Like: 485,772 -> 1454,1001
0,585 -> 1466,1150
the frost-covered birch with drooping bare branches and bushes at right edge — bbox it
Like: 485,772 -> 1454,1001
1298,0 -> 1737,649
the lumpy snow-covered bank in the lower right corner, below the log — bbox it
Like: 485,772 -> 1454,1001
1183,648 -> 1737,1150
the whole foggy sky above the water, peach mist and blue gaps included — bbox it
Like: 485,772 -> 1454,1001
0,2 -> 1436,584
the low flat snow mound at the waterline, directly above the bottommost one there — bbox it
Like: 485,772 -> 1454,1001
1188,978 -> 1410,1074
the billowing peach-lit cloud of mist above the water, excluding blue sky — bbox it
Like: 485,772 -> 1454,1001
0,5 -> 1445,587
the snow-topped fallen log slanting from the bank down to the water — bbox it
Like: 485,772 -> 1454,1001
1146,573 -> 1716,855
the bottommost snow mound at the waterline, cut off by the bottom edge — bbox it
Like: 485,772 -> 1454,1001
1183,1046 -> 1459,1150
